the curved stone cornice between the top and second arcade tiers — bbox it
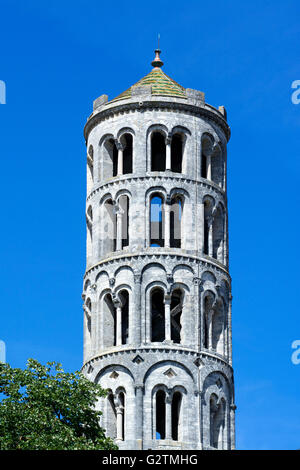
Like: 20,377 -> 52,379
86,172 -> 227,201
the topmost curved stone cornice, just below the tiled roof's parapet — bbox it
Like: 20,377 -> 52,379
84,100 -> 230,142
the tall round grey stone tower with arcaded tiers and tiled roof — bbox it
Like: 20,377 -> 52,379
82,50 -> 235,449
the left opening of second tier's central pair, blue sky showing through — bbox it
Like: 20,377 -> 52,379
150,194 -> 165,247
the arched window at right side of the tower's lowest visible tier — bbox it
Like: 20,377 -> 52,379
210,394 -> 226,449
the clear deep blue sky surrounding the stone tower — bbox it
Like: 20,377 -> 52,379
0,0 -> 300,449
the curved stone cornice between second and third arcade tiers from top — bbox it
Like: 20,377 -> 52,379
84,252 -> 230,280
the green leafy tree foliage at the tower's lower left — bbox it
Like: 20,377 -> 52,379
0,359 -> 117,450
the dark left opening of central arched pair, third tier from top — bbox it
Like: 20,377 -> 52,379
151,288 -> 165,343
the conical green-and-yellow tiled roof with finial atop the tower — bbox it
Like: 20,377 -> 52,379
111,50 -> 186,103
